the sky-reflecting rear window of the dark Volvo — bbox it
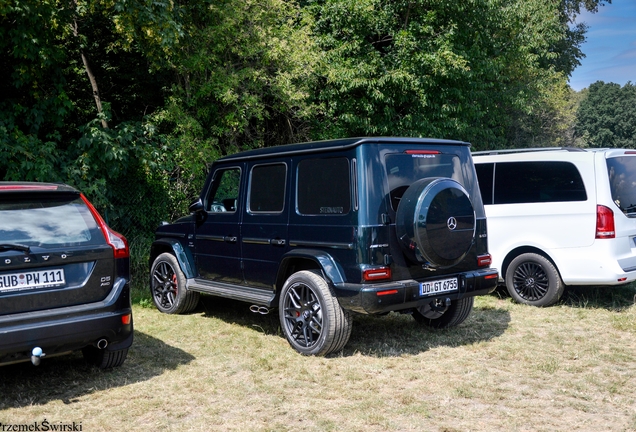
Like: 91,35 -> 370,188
0,197 -> 104,247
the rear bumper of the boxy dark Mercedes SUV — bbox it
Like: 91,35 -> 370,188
334,268 -> 498,314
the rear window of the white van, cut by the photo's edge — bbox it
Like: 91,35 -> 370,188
607,156 -> 636,217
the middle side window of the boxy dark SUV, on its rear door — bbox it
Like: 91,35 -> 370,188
248,163 -> 287,213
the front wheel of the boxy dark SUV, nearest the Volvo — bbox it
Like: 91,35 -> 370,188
150,253 -> 199,314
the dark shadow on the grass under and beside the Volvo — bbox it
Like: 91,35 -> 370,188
0,331 -> 194,410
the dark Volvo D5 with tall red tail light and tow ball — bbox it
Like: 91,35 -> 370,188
0,182 -> 133,368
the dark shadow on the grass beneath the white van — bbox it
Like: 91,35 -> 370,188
491,283 -> 636,312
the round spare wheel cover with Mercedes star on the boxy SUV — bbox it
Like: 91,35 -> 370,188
395,178 -> 476,268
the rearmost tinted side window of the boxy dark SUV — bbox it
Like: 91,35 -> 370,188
296,158 -> 351,215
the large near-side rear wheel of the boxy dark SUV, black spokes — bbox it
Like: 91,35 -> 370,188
279,270 -> 353,356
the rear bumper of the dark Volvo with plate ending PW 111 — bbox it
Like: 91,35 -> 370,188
0,278 -> 133,365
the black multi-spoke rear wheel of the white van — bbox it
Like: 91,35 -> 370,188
506,253 -> 565,307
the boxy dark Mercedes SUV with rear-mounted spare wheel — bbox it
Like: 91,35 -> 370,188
150,138 -> 498,355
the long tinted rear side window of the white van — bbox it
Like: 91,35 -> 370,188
494,162 -> 587,204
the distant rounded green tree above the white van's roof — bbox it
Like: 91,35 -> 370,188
575,81 -> 636,148
